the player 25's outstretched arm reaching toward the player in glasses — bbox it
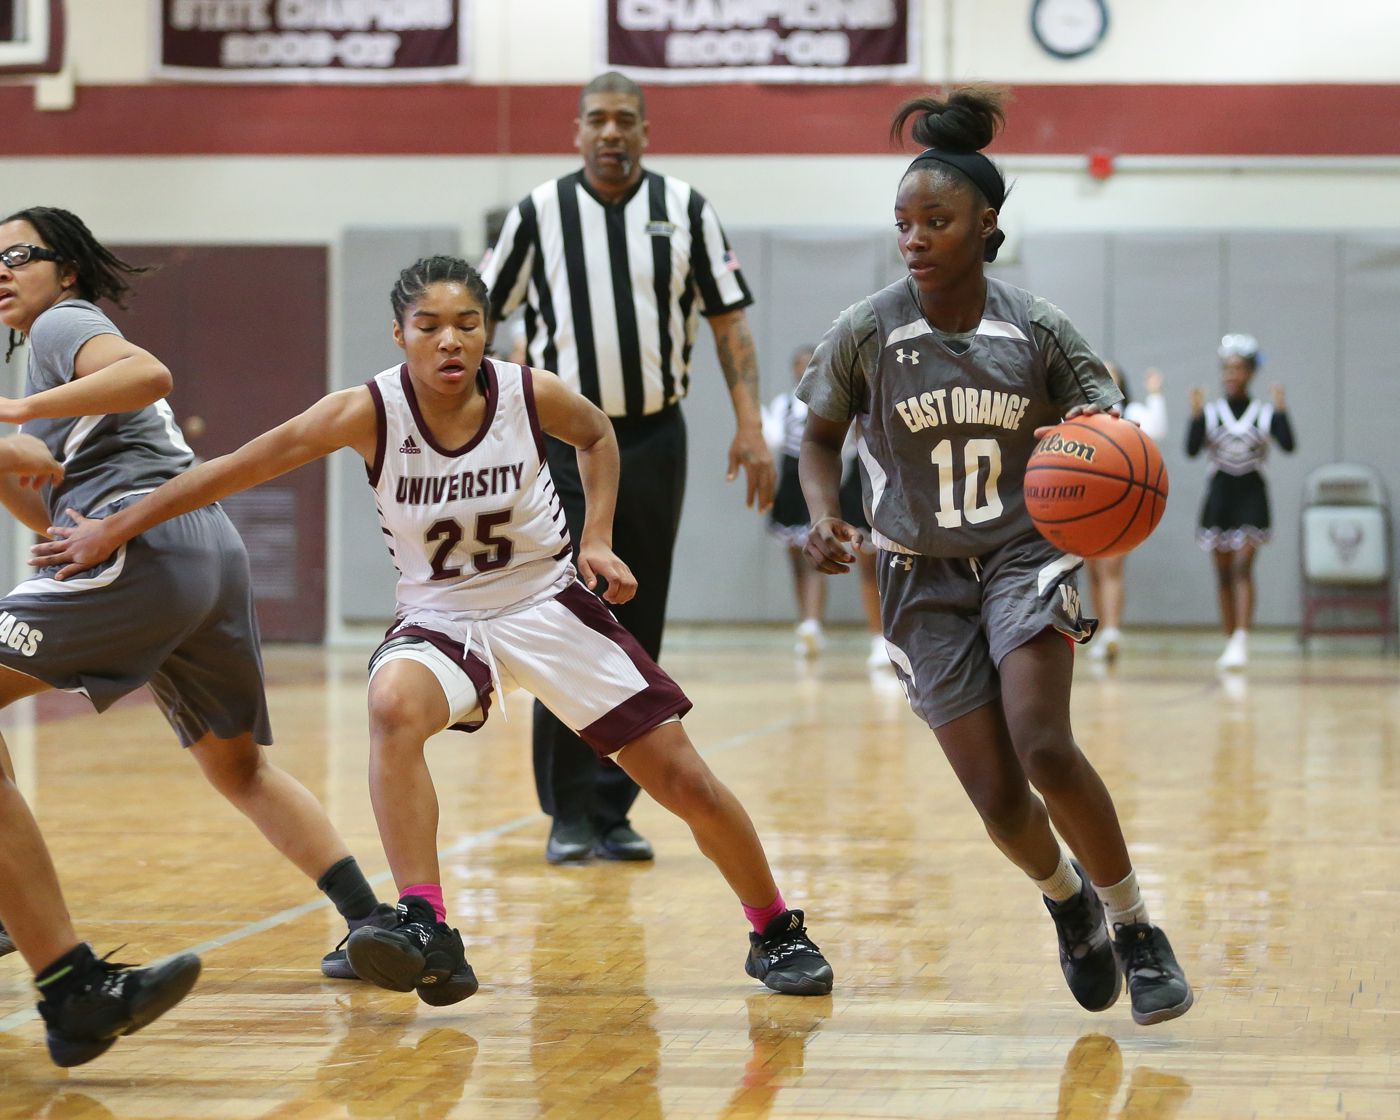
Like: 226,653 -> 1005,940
29,386 -> 378,580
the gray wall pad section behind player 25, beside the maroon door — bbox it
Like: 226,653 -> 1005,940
330,228 -> 459,626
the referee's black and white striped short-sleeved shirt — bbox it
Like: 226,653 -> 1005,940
482,171 -> 753,417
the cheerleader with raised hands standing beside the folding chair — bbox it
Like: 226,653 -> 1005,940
1186,335 -> 1295,669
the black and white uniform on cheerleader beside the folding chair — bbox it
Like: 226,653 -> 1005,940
1186,396 -> 1295,552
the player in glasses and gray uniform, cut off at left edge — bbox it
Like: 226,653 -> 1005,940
0,207 -> 392,1065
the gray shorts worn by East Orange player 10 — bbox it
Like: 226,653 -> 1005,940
875,533 -> 1099,728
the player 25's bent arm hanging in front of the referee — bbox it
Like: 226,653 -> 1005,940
533,370 -> 637,603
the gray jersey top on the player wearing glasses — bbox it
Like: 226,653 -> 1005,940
22,300 -> 195,519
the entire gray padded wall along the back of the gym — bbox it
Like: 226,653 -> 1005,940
327,230 -> 1400,635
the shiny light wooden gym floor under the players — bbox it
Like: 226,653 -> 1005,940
0,629 -> 1400,1120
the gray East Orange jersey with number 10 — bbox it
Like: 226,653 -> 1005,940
858,277 -> 1061,557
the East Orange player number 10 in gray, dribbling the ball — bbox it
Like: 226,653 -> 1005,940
798,88 -> 1191,1023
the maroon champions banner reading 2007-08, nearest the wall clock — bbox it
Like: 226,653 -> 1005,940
598,0 -> 920,83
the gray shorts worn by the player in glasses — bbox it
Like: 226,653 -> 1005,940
0,498 -> 272,746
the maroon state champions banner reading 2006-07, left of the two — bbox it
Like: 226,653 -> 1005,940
151,0 -> 470,84
